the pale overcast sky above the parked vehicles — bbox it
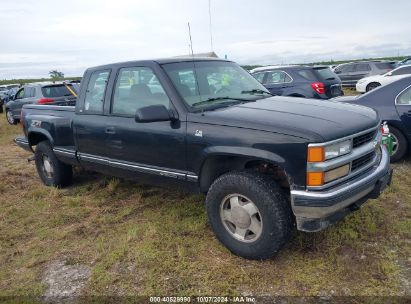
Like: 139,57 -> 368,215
0,0 -> 411,79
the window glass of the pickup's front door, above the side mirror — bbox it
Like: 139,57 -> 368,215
111,67 -> 170,116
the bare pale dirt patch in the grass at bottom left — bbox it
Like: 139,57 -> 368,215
43,261 -> 91,301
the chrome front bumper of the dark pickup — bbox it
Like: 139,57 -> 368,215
291,146 -> 392,231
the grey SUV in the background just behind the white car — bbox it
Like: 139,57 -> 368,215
334,61 -> 392,87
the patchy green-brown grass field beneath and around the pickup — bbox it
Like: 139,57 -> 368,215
0,111 -> 411,296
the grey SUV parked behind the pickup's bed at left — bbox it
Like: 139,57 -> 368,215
6,83 -> 76,125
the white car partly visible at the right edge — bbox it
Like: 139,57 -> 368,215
355,65 -> 411,93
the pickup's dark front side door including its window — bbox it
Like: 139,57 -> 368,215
83,66 -> 186,179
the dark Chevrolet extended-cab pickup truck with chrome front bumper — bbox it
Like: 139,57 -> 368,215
15,58 -> 392,259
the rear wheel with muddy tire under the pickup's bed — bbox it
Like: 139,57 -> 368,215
34,141 -> 73,188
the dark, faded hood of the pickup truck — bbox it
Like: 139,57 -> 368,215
188,96 -> 379,142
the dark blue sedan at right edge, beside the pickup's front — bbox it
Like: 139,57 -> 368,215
335,75 -> 411,162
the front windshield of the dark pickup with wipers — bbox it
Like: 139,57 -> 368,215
162,61 -> 271,110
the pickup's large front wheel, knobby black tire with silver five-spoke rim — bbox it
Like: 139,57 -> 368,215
206,171 -> 293,260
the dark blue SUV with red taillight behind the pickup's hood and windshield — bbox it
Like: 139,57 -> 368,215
251,65 -> 344,99
